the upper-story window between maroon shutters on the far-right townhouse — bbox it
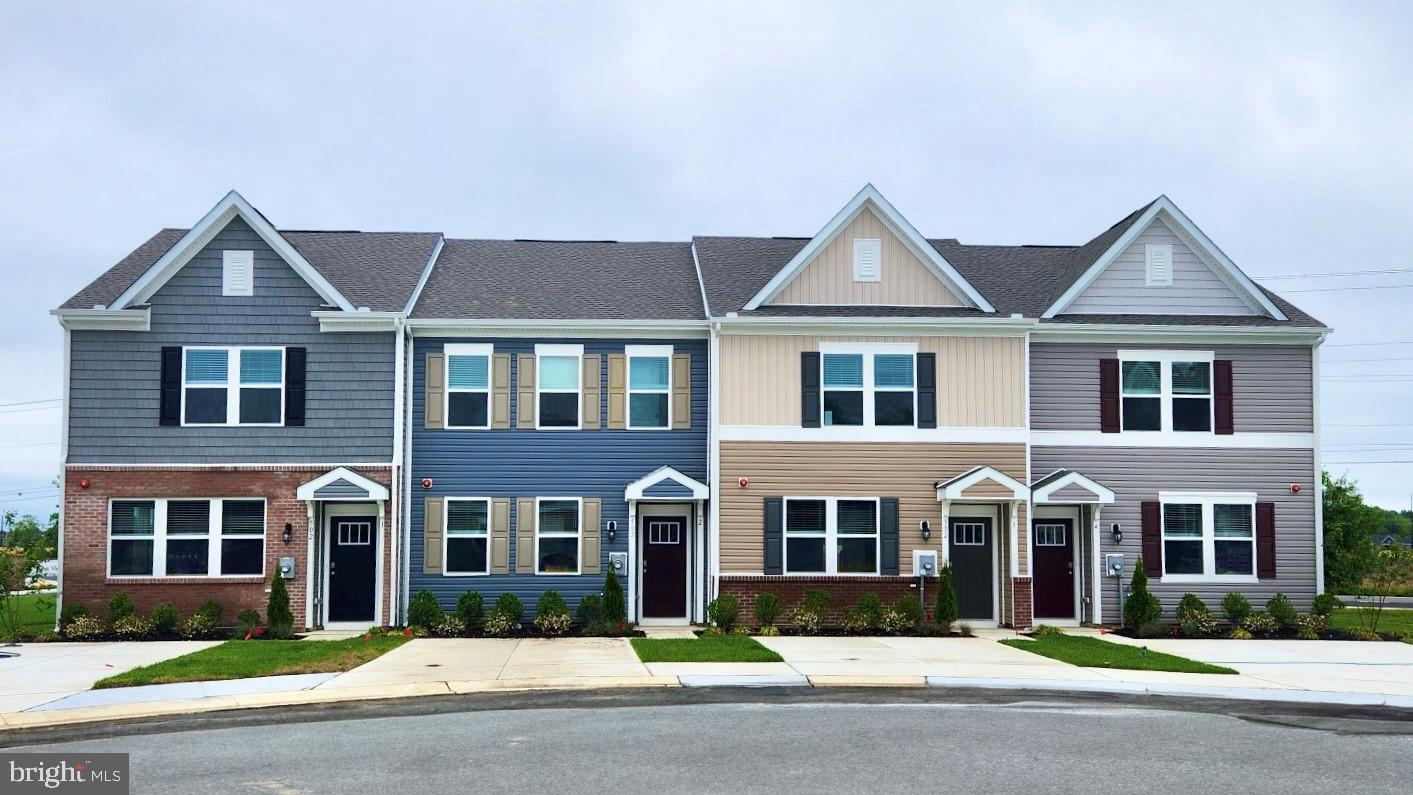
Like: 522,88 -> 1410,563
1119,350 -> 1212,432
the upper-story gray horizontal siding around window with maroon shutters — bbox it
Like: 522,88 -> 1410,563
1030,343 -> 1314,432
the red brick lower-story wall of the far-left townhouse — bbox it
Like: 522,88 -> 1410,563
61,466 -> 396,627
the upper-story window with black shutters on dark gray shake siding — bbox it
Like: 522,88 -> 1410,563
182,347 -> 284,425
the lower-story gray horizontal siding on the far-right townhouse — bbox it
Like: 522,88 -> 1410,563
1030,446 -> 1316,623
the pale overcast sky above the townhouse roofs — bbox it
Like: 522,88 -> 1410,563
0,0 -> 1413,513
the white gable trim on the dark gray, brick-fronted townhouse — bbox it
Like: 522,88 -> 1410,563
109,191 -> 355,312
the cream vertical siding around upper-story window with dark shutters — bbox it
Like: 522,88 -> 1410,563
723,335 -> 1023,428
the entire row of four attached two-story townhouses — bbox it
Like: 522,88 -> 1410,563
55,186 -> 1330,627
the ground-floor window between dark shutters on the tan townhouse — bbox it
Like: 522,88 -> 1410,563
784,497 -> 879,575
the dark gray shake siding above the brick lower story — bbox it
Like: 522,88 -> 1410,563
68,219 -> 396,463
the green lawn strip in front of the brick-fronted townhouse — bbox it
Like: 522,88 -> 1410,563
93,635 -> 407,689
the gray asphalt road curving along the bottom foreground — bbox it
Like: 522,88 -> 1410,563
8,692 -> 1413,795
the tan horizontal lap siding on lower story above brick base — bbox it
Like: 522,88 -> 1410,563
721,442 -> 1026,576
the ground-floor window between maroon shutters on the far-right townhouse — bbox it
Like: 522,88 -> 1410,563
1159,491 -> 1256,582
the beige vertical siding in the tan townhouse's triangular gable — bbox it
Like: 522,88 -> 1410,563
770,210 -> 962,306
